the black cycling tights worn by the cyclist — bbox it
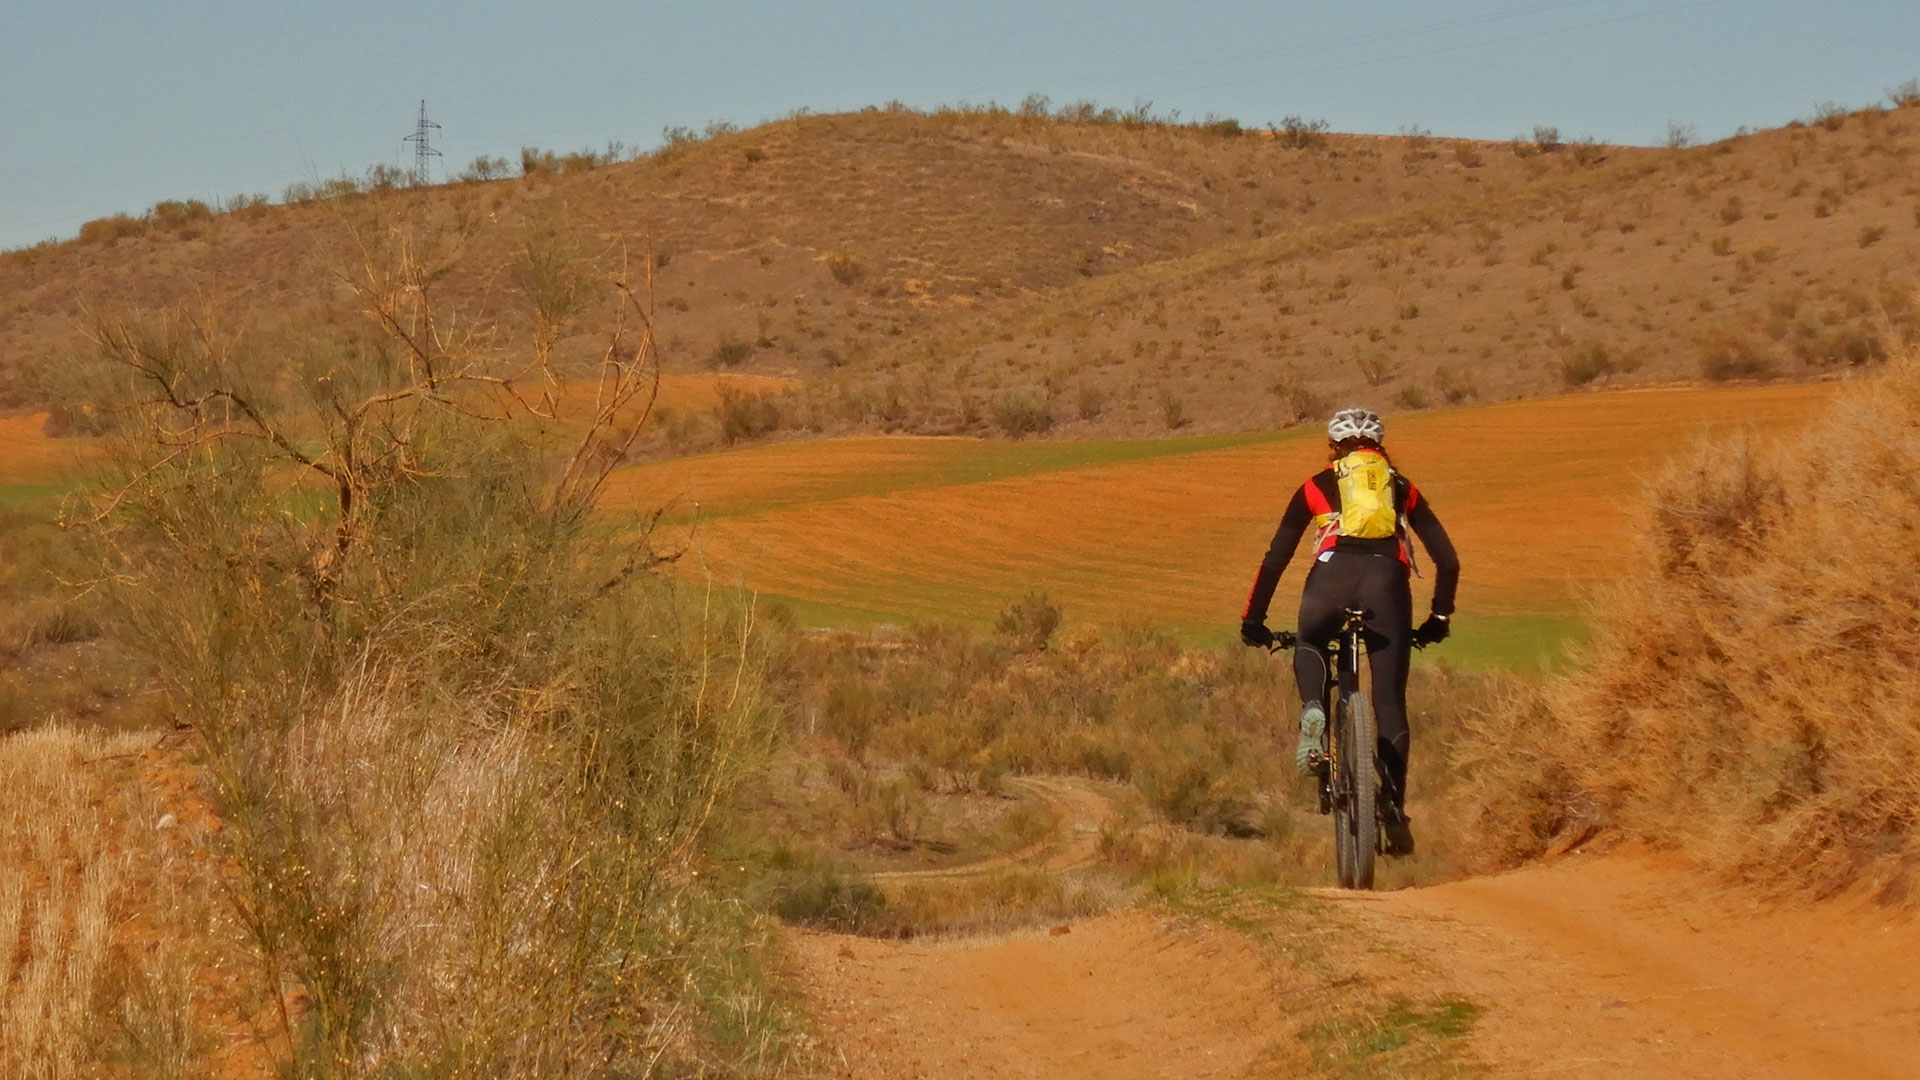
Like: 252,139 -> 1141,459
1294,550 -> 1413,805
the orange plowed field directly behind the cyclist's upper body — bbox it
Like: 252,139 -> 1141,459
614,384 -> 1832,661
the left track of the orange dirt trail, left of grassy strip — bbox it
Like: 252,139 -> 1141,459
789,911 -> 1284,1080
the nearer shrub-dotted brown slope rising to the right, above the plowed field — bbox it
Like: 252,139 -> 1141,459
898,110 -> 1920,430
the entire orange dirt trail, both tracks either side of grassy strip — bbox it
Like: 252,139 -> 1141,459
791,851 -> 1920,1080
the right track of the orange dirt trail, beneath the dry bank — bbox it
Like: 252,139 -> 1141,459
1346,851 -> 1920,1080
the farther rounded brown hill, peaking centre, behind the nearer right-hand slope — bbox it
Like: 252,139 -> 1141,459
0,111 -> 1559,407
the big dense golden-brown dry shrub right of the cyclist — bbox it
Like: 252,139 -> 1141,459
1459,340 -> 1920,897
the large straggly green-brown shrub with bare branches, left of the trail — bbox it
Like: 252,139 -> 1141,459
75,214 -> 780,1080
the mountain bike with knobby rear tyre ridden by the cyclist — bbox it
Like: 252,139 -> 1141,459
1271,607 -> 1388,890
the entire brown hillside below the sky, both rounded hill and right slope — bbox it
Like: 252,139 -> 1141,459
0,99 -> 1920,434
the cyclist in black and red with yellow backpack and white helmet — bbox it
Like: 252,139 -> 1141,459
1240,409 -> 1459,855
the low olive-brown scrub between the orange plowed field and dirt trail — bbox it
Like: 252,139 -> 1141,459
735,596 -> 1486,936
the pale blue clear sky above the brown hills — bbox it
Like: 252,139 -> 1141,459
0,0 -> 1920,248
